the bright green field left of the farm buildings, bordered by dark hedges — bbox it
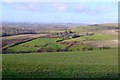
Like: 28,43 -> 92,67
7,38 -> 64,52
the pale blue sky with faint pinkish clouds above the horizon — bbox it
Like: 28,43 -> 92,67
0,0 -> 118,24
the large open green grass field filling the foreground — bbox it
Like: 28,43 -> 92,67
2,49 -> 118,78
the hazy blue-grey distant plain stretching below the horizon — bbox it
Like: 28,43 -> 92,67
1,22 -> 86,36
